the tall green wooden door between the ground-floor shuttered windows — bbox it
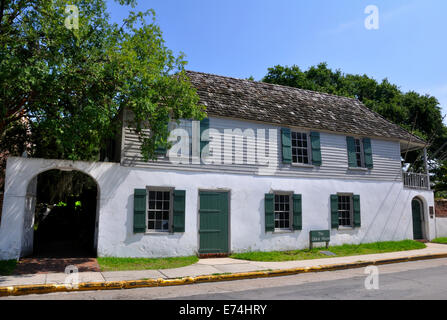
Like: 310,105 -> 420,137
199,191 -> 229,253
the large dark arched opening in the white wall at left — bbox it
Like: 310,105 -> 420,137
24,169 -> 99,258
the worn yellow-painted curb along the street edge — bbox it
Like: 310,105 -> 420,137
0,253 -> 447,297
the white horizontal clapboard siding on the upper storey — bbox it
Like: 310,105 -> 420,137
121,112 -> 402,181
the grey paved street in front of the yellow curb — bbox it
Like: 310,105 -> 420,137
3,259 -> 447,300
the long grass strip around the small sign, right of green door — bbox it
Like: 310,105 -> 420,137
230,240 -> 426,261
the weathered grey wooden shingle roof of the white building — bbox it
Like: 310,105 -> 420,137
187,71 -> 426,149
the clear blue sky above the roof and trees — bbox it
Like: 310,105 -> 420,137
108,0 -> 447,123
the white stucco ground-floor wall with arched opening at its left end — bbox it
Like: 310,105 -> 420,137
0,158 -> 435,259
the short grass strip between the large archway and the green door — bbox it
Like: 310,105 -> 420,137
97,256 -> 199,271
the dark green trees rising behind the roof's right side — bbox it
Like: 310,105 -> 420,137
263,63 -> 447,192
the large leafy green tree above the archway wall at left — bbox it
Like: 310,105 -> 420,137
0,0 -> 204,164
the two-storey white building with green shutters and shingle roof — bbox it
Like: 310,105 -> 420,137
0,72 -> 436,259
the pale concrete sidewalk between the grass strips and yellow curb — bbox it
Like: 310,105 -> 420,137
0,243 -> 447,287
